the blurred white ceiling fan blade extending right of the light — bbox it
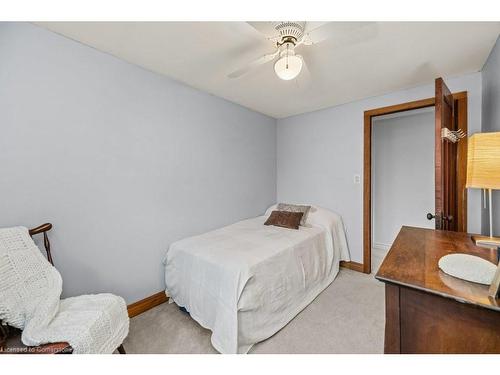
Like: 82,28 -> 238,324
303,22 -> 378,45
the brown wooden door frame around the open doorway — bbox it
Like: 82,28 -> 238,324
358,91 -> 467,273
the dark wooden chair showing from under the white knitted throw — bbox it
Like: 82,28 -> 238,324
0,223 -> 126,354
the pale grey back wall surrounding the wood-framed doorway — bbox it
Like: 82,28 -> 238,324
277,72 -> 481,262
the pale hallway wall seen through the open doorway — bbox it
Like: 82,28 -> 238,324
372,107 -> 435,249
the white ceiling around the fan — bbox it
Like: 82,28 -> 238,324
37,22 -> 500,118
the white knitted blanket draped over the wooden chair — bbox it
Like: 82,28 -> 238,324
0,227 -> 129,354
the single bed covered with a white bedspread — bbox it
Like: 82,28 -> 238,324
164,206 -> 349,353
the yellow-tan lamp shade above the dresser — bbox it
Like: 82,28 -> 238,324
466,132 -> 500,189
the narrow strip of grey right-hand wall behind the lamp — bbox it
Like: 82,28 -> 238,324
482,39 -> 500,236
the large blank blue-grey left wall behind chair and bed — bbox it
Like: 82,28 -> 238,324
0,23 -> 276,302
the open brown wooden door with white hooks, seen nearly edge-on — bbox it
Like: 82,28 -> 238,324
434,78 -> 458,231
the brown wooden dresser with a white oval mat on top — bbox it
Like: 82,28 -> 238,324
375,227 -> 500,353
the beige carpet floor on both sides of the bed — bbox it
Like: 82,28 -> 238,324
124,269 -> 384,354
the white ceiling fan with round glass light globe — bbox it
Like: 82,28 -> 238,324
228,21 -> 374,81
